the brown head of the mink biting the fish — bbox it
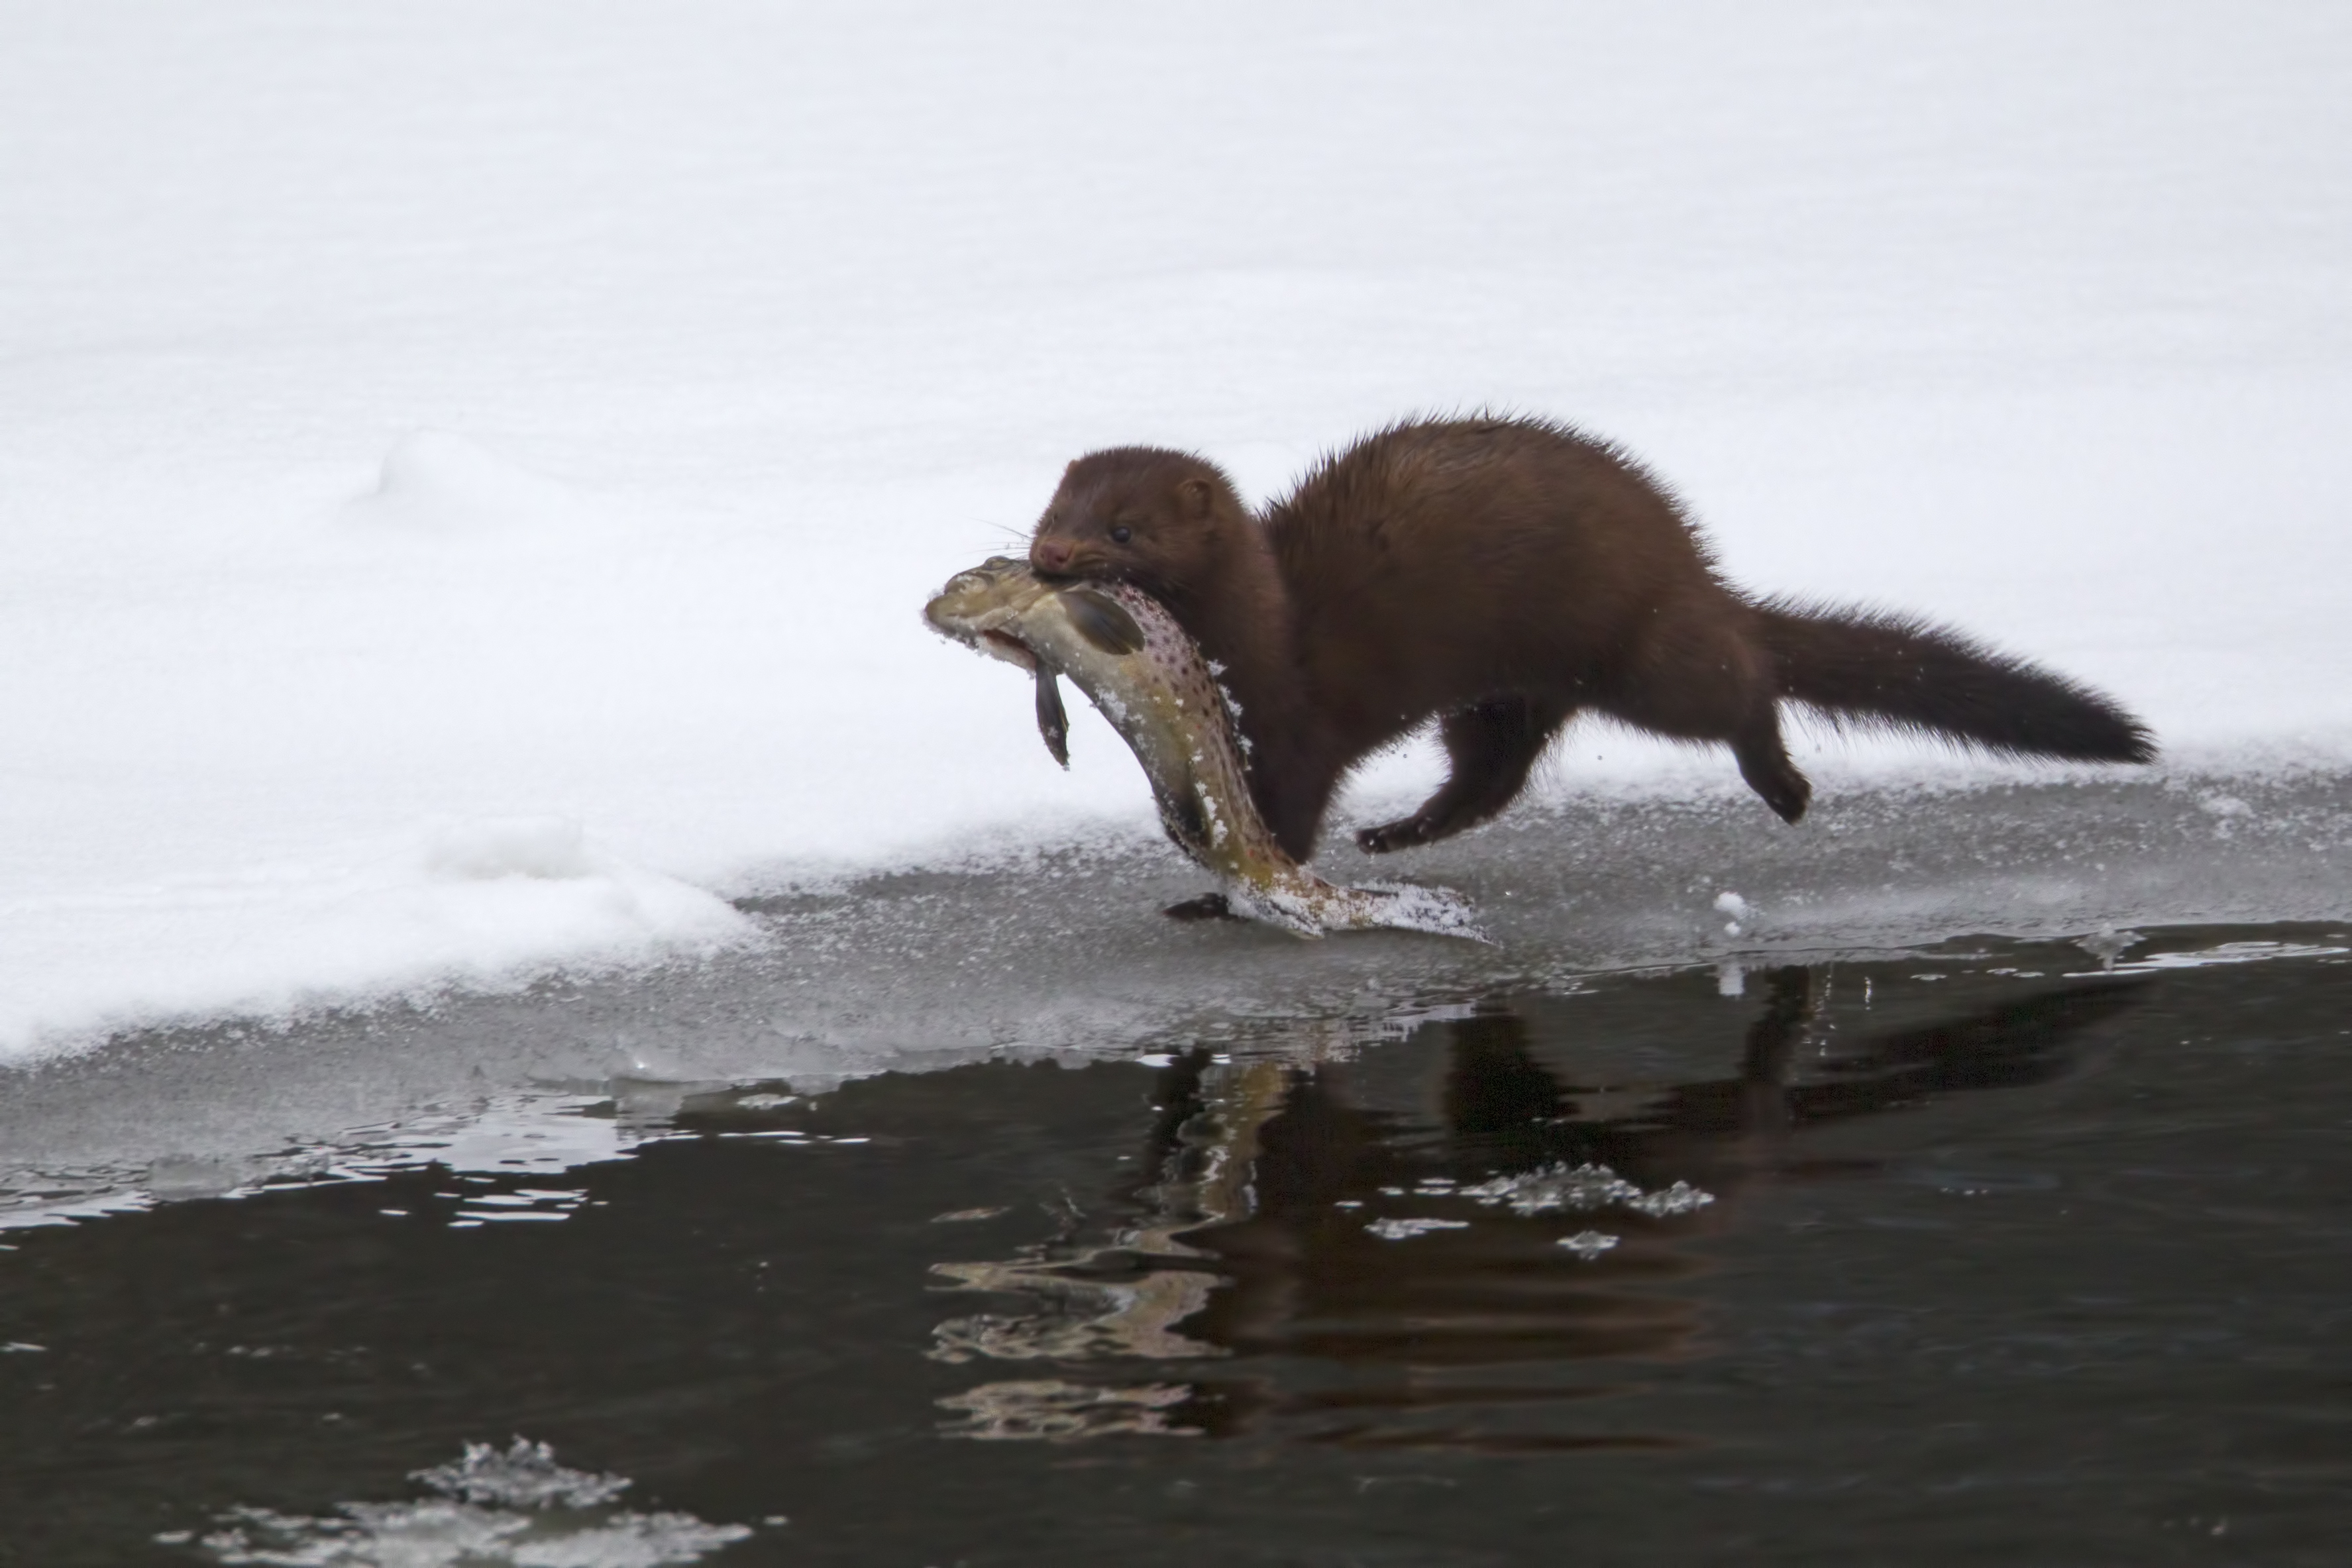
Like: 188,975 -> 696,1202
1030,446 -> 1247,597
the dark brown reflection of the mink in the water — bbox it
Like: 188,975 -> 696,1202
1148,982 -> 2147,1453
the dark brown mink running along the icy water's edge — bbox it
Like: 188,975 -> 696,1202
1030,421 -> 2155,861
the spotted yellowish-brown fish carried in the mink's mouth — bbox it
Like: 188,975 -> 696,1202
922,554 -> 1475,935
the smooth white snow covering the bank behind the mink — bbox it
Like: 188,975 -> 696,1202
0,0 -> 2352,1058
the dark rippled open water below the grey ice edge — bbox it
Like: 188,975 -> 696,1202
0,929 -> 2352,1568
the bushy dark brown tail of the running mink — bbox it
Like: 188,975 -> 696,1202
1757,600 -> 2157,762
